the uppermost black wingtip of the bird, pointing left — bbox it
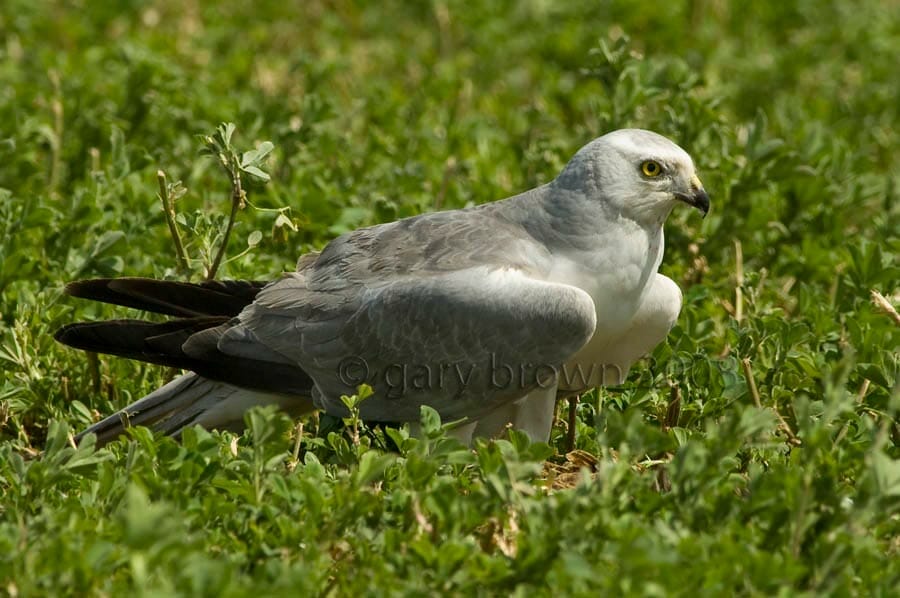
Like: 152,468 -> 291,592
66,278 -> 267,318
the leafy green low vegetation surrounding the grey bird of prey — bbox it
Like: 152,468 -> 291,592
0,0 -> 900,596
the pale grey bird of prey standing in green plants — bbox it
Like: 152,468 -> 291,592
56,129 -> 709,443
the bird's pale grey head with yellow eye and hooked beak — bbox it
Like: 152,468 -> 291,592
556,129 -> 709,224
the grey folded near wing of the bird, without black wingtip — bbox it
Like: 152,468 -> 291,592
219,266 -> 596,421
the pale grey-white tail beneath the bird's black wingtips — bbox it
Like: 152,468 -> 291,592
75,373 -> 315,446
